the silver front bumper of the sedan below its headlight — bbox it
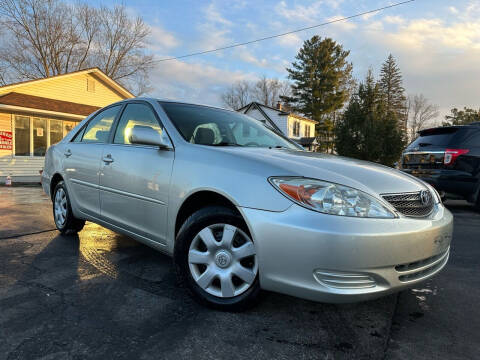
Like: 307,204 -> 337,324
239,204 -> 453,303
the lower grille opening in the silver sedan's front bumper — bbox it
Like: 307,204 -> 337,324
395,247 -> 450,282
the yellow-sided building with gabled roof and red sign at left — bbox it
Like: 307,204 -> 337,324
0,68 -> 134,183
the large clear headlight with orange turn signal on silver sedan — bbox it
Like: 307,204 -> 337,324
268,177 -> 395,219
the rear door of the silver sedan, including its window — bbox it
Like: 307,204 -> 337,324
63,105 -> 121,217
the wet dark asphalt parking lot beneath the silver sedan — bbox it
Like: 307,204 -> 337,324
0,187 -> 480,359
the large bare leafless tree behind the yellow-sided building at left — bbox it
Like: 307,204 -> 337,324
0,0 -> 154,92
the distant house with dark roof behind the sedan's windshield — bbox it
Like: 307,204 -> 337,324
237,101 -> 318,151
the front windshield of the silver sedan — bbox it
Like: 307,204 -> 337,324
160,102 -> 300,150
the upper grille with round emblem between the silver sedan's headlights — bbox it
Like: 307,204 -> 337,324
382,190 -> 434,217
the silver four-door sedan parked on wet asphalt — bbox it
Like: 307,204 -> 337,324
42,98 -> 452,310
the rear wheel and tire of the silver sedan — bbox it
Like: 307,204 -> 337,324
52,181 -> 85,234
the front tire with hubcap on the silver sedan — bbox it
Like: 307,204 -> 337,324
174,206 -> 260,312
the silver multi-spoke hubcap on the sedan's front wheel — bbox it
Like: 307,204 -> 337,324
188,224 -> 258,298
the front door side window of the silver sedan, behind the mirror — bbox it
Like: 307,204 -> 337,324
113,104 -> 163,144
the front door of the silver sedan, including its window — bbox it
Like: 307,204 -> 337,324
100,102 -> 174,243
